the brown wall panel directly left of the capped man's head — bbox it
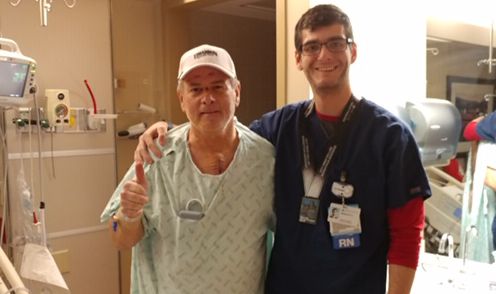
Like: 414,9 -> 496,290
111,0 -> 168,175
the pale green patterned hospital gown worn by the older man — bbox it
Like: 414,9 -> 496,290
101,123 -> 275,294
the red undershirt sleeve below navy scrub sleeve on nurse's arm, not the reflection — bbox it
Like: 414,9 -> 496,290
388,197 -> 425,269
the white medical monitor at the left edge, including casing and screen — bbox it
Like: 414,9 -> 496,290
0,38 -> 36,106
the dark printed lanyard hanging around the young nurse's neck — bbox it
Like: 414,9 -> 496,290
299,95 -> 360,198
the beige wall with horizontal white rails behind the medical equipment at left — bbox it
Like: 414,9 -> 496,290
0,0 -> 119,294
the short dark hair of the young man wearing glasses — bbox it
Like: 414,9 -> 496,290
295,4 -> 353,52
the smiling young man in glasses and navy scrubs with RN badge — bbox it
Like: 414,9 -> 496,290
135,5 -> 431,294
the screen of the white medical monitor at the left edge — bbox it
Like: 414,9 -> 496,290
0,60 -> 29,98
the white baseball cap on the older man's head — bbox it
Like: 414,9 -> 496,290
177,44 -> 236,80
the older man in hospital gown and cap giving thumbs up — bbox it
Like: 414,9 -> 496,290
101,45 -> 274,294
